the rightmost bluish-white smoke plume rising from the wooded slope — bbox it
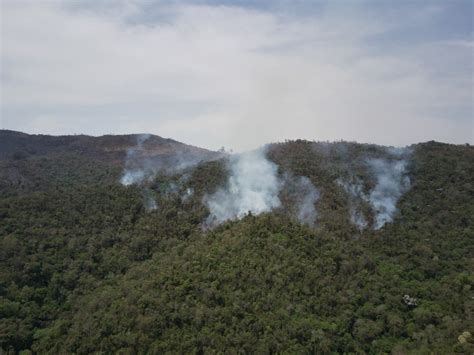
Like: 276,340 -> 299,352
367,159 -> 410,229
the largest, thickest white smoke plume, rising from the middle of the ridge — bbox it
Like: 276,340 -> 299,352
204,149 -> 281,225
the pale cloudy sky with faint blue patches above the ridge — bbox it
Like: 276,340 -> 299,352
0,0 -> 474,151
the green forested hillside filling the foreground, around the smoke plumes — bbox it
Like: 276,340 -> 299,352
0,132 -> 474,354
